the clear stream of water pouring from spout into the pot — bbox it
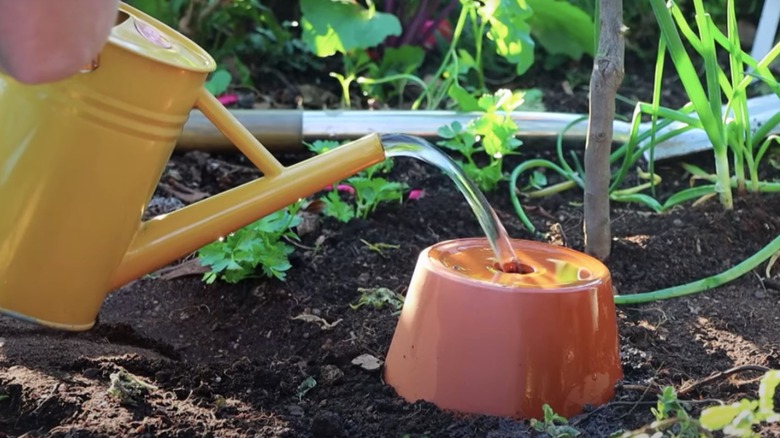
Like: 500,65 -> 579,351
381,134 -> 522,272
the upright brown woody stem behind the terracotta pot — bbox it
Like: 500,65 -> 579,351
584,0 -> 625,260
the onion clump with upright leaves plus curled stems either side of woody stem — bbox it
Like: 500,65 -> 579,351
510,0 -> 780,231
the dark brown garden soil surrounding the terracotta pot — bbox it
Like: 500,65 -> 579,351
0,49 -> 780,438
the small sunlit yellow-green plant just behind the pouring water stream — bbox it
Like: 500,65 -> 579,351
437,89 -> 525,191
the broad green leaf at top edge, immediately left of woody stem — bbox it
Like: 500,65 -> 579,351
527,0 -> 596,60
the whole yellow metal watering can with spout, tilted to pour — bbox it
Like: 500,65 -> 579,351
0,3 -> 385,331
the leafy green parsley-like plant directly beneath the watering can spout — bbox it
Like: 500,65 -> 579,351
198,202 -> 303,284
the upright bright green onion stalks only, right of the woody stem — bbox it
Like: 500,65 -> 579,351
650,0 -> 780,209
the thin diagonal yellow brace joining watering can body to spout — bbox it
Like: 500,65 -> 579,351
195,87 -> 284,177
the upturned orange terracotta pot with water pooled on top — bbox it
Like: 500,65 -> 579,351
385,238 -> 623,418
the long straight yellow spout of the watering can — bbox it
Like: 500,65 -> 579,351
112,127 -> 385,289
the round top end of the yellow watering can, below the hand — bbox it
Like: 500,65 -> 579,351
108,2 -> 216,73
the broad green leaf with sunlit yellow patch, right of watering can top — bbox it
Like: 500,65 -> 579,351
301,0 -> 401,57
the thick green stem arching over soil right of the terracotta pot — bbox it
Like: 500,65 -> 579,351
615,236 -> 780,304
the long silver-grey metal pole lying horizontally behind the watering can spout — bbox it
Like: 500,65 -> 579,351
177,94 -> 780,161
